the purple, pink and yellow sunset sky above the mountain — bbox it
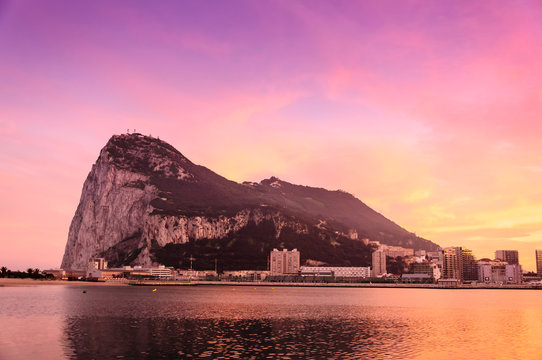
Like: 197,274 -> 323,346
0,0 -> 542,270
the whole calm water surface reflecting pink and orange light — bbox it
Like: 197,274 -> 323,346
0,285 -> 542,360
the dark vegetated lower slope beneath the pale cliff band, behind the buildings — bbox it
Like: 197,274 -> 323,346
151,220 -> 372,271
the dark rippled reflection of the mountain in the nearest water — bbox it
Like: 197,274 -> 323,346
65,317 -> 415,359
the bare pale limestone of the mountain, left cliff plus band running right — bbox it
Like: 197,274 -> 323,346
61,135 -> 308,269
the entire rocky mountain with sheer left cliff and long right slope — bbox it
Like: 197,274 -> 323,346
62,133 -> 438,269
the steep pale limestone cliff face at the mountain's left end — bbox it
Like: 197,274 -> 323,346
62,145 -> 157,269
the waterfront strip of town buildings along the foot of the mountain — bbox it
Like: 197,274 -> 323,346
38,242 -> 542,288
